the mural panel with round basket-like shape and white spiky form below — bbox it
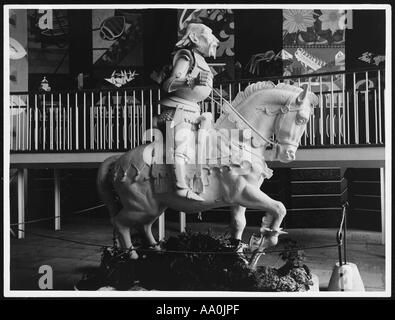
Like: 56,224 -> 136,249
92,9 -> 143,87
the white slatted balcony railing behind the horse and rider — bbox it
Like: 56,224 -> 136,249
10,69 -> 385,152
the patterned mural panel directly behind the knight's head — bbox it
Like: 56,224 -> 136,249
178,9 -> 235,81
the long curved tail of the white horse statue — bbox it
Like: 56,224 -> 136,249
96,156 -> 120,218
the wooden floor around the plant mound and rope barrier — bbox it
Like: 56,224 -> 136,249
10,217 -> 385,291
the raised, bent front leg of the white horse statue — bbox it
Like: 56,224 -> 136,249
237,184 -> 286,245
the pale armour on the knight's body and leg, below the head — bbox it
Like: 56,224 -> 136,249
158,49 -> 212,201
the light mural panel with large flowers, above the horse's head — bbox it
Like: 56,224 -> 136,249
283,9 -> 352,91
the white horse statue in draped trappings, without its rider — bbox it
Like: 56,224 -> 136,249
97,81 -> 318,258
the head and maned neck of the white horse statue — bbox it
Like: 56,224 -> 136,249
216,81 -> 318,162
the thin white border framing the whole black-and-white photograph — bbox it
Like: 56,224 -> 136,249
3,4 -> 392,298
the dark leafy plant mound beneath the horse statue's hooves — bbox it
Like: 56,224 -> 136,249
75,232 -> 318,292
